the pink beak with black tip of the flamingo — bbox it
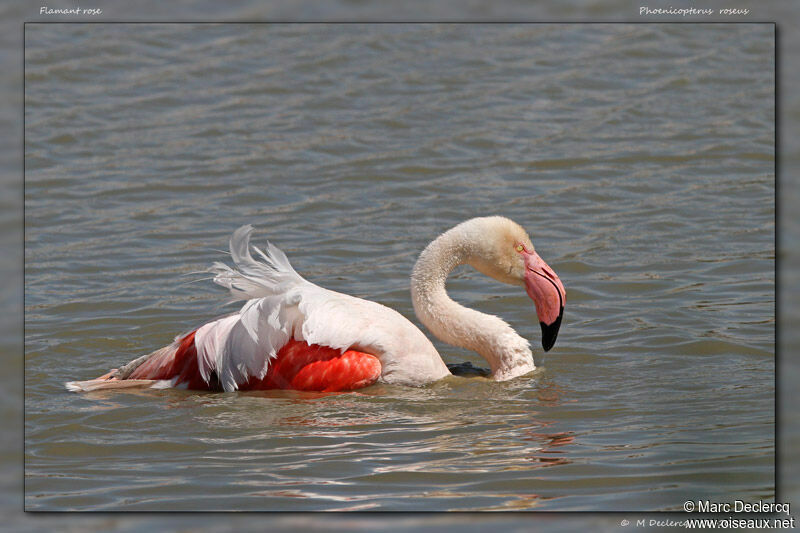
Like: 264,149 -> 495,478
521,250 -> 567,351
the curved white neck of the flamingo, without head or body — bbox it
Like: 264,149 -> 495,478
411,228 -> 535,381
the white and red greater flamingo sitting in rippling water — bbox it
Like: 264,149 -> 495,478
66,216 -> 566,391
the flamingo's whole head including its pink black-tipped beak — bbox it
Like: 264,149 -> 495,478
471,217 -> 567,351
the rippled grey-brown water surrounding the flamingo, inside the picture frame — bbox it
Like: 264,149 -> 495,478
25,24 -> 775,510
